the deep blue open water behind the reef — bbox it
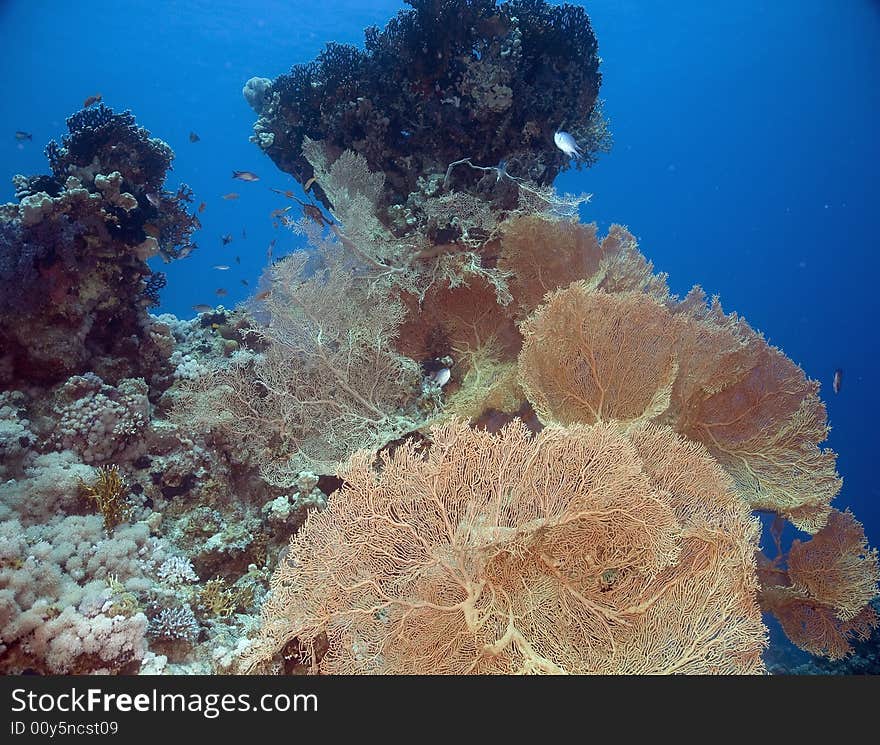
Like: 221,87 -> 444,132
0,0 -> 880,664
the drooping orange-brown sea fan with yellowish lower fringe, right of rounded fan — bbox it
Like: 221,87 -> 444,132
666,289 -> 842,533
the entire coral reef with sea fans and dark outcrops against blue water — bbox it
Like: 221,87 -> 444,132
0,0 -> 878,674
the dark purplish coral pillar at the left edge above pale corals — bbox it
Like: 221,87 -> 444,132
0,104 -> 199,394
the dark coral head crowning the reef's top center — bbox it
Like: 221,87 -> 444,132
245,0 -> 608,235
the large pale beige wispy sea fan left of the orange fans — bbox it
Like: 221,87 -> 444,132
177,248 -> 421,486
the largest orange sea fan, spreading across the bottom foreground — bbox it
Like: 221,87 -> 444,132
247,421 -> 765,673
